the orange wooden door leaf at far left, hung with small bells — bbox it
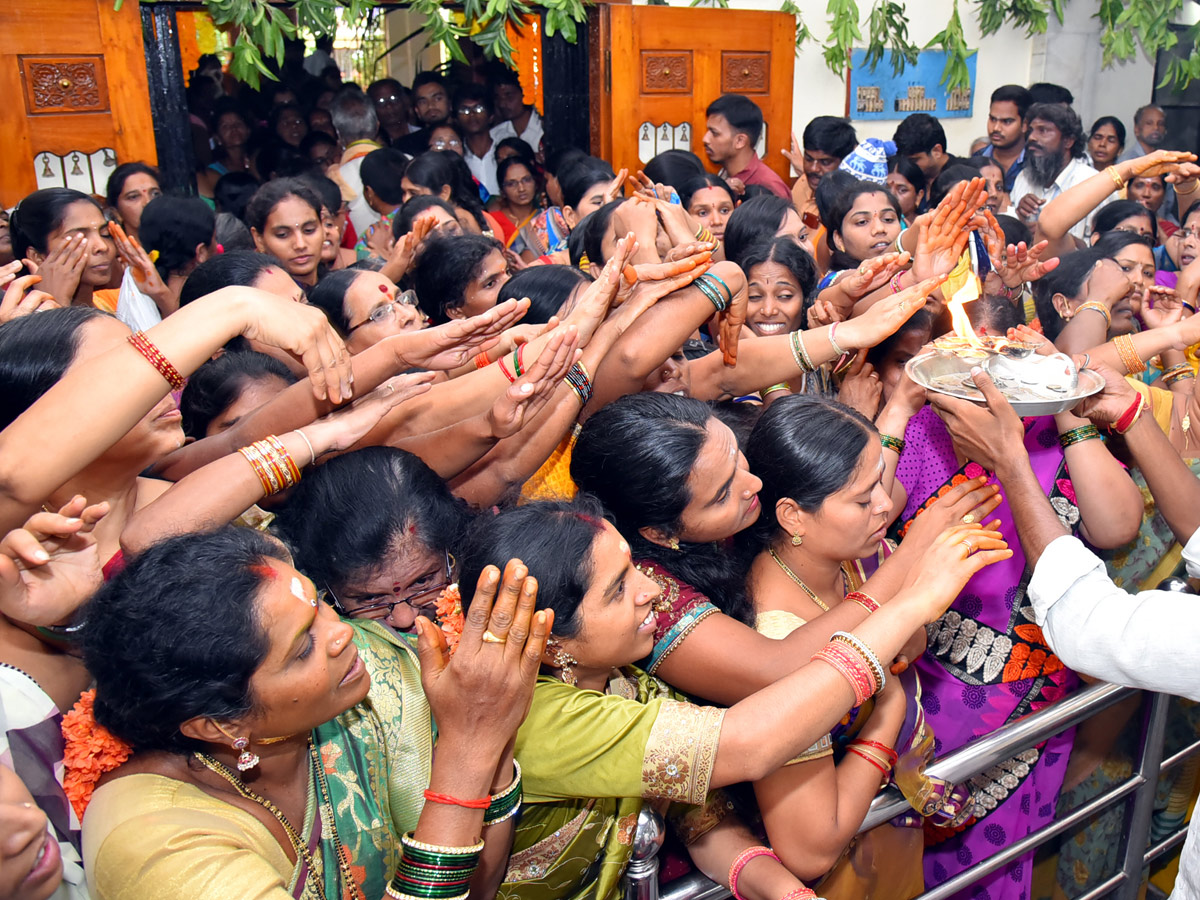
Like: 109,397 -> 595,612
0,0 -> 158,206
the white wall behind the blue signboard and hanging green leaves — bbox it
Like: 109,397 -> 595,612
634,0 -> 1153,160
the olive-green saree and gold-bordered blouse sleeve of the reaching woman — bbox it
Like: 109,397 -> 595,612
497,666 -> 728,900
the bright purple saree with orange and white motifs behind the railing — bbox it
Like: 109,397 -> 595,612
896,406 -> 1079,900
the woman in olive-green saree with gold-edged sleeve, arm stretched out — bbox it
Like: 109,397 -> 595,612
462,502 -> 1008,900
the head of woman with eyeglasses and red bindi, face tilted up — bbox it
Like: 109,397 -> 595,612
308,269 -> 428,353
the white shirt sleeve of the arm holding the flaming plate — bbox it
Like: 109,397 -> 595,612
1028,532 -> 1200,701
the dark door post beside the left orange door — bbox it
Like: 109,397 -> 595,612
140,4 -> 196,194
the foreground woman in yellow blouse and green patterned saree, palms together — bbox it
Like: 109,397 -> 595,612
78,528 -> 553,900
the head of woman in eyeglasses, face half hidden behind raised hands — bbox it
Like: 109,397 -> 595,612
278,448 -> 472,632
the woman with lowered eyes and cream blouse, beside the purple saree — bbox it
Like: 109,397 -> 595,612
746,397 -> 1000,900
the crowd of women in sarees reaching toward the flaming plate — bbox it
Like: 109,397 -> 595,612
0,61 -> 1200,900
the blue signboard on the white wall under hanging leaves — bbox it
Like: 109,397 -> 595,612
850,50 -> 978,119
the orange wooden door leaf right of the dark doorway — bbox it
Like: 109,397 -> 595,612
593,5 -> 796,179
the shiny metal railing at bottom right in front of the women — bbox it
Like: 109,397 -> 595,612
625,578 -> 1200,900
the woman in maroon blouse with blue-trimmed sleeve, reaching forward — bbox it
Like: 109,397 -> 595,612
571,391 -> 1003,710
